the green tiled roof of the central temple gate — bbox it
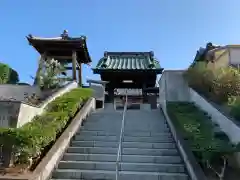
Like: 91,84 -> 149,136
95,52 -> 162,70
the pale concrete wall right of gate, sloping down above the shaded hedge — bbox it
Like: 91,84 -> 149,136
159,71 -> 240,167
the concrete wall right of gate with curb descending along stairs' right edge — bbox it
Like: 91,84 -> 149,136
159,71 -> 206,180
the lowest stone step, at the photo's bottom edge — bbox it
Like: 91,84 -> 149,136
53,169 -> 188,180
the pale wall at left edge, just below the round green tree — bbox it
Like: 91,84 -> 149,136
0,84 -> 41,101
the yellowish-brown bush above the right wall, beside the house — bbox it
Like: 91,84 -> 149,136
184,62 -> 240,103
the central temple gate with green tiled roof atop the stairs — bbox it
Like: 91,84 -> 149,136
93,52 -> 163,105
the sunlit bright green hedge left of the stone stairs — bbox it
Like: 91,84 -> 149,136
0,88 -> 92,164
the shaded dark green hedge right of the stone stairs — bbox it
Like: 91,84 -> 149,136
167,102 -> 239,165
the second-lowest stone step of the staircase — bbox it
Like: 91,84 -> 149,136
58,161 -> 186,173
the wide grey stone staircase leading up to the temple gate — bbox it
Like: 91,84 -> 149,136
52,107 -> 190,180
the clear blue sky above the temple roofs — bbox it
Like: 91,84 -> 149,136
0,0 -> 240,82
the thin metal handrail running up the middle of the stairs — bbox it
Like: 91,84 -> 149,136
116,91 -> 128,180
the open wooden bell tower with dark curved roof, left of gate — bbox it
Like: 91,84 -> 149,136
27,30 -> 92,85
